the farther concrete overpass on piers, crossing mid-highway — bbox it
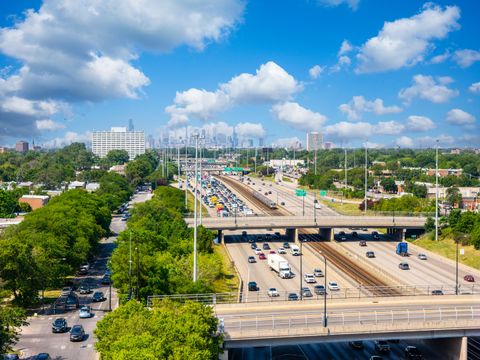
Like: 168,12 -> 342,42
185,215 -> 426,241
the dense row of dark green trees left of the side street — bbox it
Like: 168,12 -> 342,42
0,190 -> 111,306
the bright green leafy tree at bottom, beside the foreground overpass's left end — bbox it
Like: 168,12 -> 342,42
95,301 -> 222,360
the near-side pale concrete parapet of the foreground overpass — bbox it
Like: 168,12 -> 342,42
219,306 -> 480,340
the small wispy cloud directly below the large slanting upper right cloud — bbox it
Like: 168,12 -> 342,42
398,75 -> 458,104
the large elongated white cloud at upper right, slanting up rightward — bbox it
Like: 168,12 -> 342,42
356,3 -> 460,73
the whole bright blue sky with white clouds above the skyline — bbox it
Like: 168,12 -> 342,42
0,0 -> 480,147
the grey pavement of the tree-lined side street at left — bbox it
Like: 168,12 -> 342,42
14,193 -> 152,360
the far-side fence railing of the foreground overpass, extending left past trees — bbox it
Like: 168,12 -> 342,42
147,284 -> 480,306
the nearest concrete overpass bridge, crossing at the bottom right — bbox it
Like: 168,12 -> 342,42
214,296 -> 480,359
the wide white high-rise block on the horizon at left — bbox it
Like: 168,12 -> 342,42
92,127 -> 145,160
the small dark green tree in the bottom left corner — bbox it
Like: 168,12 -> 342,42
0,306 -> 28,354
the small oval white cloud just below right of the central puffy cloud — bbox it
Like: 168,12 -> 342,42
271,102 -> 327,130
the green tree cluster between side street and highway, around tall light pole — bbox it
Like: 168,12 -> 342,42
111,186 -> 222,300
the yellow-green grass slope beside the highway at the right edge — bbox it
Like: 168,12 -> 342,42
411,234 -> 480,270
